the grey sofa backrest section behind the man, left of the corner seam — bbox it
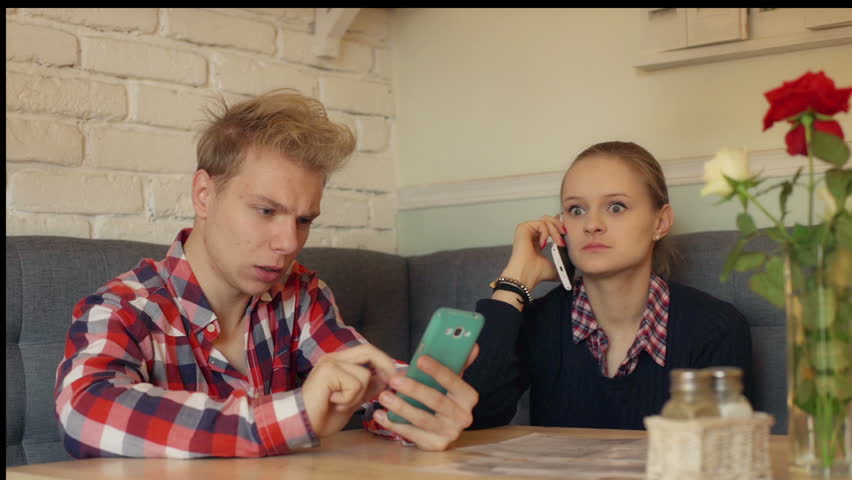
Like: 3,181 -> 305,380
6,236 -> 410,466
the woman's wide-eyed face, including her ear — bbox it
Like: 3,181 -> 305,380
562,155 -> 671,278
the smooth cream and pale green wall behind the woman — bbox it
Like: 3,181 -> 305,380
391,9 -> 852,254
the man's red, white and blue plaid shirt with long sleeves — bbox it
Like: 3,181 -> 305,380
54,228 -> 398,458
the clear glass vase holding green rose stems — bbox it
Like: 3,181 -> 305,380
784,245 -> 852,478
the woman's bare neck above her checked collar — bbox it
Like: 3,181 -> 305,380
583,264 -> 651,334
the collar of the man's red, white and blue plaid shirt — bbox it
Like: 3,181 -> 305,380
161,227 -> 288,334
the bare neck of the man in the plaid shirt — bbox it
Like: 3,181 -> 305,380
184,226 -> 250,331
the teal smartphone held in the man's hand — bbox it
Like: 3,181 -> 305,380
388,307 -> 485,423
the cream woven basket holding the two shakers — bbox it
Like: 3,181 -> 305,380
645,412 -> 775,480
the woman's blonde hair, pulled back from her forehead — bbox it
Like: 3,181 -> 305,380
559,141 -> 680,278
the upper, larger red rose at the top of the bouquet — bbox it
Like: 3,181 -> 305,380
763,71 -> 852,130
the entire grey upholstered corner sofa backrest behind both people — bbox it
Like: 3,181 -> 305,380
6,232 -> 787,466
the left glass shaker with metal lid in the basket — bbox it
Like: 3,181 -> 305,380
661,368 -> 719,420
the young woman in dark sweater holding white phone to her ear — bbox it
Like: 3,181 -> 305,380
465,142 -> 751,429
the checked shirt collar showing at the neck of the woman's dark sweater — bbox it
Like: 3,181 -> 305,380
571,273 -> 669,377
